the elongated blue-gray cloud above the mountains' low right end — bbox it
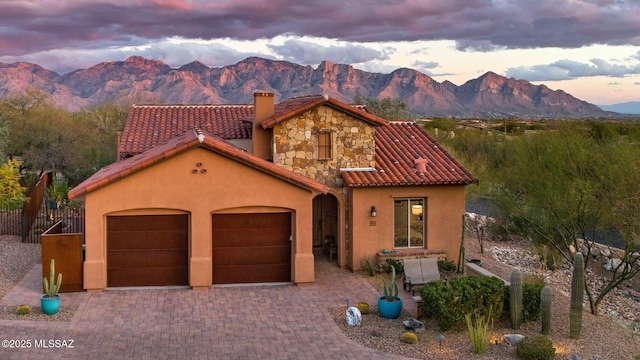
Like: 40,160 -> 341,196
507,59 -> 640,81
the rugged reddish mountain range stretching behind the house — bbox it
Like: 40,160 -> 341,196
0,56 -> 619,118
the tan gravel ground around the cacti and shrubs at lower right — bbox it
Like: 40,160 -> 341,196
329,239 -> 640,360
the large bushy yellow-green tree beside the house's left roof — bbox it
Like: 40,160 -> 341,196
0,91 -> 129,186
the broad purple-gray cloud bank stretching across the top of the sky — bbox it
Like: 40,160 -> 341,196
0,0 -> 640,56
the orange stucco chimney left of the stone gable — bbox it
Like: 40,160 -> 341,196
252,91 -> 273,160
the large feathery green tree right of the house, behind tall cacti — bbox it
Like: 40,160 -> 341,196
491,124 -> 640,315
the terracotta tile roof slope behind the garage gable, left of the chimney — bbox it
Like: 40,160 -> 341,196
118,105 -> 253,156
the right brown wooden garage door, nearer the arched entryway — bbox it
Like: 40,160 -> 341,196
212,213 -> 291,284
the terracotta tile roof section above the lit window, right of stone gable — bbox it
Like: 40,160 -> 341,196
342,122 -> 478,187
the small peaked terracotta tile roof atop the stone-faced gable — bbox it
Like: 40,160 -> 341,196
260,94 -> 387,129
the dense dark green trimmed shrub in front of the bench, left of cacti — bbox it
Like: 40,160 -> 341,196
420,276 -> 504,331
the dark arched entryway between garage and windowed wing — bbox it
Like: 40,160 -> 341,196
313,194 -> 340,262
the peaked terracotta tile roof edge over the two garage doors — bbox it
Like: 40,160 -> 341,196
69,130 -> 329,199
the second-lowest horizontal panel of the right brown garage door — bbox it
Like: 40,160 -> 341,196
213,247 -> 291,266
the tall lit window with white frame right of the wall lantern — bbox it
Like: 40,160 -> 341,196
393,198 -> 425,248
